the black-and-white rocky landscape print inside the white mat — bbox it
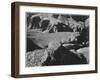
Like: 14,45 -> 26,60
25,12 -> 90,67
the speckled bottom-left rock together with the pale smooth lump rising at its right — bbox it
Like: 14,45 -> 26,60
26,42 -> 61,67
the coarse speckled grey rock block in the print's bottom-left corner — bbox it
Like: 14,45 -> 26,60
26,49 -> 48,67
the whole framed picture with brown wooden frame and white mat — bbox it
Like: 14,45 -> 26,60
11,2 -> 97,77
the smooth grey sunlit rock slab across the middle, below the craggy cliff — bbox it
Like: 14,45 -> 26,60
27,32 -> 80,48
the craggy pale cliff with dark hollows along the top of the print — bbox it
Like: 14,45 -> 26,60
27,13 -> 89,32
